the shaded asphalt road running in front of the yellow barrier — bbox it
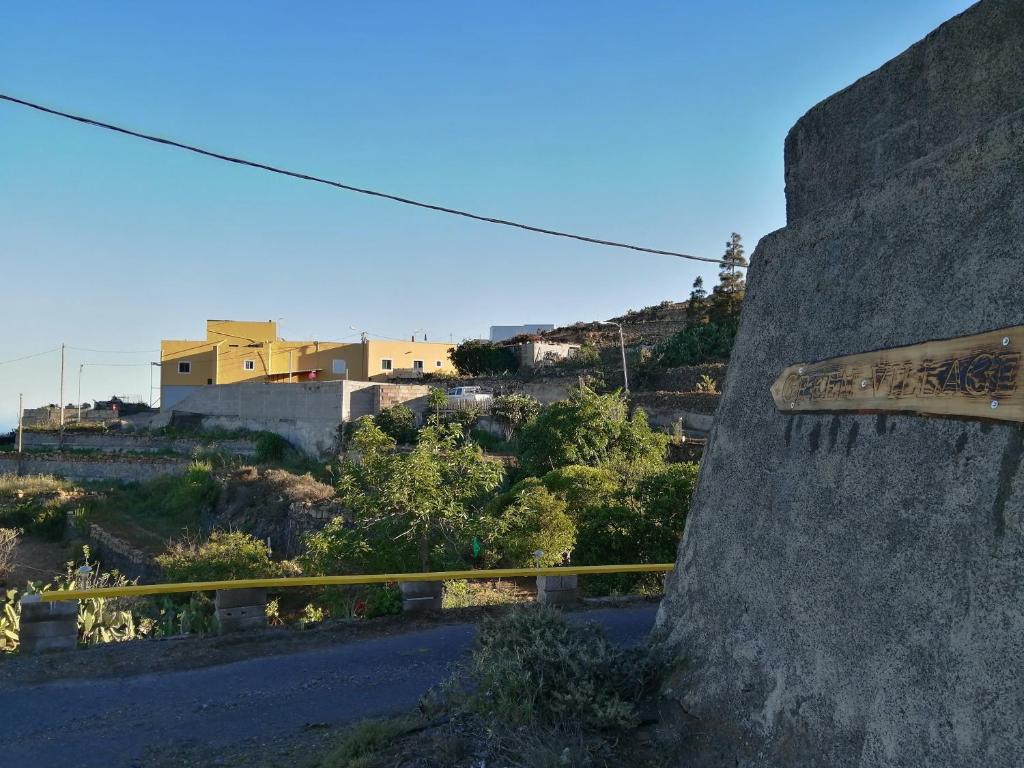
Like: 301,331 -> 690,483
0,604 -> 656,768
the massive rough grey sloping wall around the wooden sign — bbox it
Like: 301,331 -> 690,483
655,0 -> 1024,768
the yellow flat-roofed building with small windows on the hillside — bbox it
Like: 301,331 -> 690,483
160,321 -> 455,409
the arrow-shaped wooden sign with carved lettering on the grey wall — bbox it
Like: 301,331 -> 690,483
771,326 -> 1024,422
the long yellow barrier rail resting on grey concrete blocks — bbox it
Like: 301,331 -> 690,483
40,562 -> 676,602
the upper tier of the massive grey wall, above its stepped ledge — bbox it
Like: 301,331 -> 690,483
785,0 -> 1024,222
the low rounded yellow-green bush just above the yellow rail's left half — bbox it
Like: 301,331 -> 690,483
157,530 -> 281,582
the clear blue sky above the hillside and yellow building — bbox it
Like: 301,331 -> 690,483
0,0 -> 969,428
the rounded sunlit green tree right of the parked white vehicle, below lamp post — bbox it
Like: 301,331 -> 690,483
519,386 -> 668,475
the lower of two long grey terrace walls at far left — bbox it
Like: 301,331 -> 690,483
0,454 -> 189,482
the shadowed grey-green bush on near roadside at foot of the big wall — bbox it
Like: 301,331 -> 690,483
436,605 -> 651,728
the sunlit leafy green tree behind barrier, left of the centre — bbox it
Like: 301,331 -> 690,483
304,419 -> 503,572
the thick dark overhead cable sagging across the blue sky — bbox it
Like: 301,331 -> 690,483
0,93 -> 726,264
